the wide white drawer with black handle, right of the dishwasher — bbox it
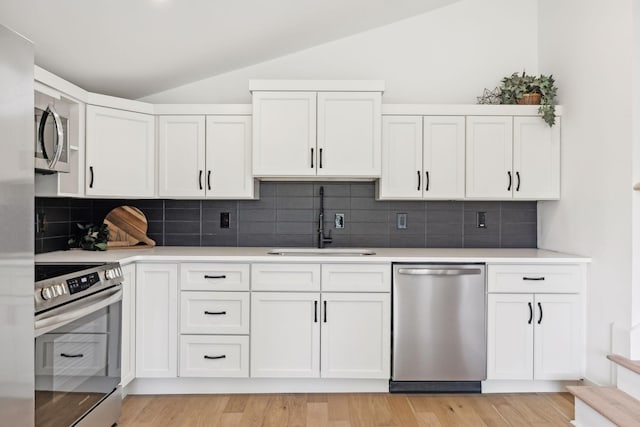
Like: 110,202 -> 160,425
487,264 -> 582,293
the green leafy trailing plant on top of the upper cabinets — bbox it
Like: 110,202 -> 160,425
500,71 -> 558,126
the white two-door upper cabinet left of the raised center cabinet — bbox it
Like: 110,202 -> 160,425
158,115 -> 254,199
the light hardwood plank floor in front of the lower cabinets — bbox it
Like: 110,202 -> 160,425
118,393 -> 573,427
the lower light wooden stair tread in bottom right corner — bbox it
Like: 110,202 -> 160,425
567,386 -> 640,427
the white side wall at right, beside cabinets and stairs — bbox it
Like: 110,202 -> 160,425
538,0 -> 634,383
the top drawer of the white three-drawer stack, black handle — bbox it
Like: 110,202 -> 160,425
180,263 -> 249,291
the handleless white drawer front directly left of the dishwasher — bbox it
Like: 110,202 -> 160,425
322,264 -> 391,292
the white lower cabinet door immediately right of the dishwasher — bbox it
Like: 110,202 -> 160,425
487,294 -> 534,380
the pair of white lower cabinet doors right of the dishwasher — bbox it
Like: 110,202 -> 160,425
487,294 -> 583,380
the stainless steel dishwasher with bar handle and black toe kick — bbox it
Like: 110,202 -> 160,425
389,264 -> 487,393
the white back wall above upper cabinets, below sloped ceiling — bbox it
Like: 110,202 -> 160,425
141,0 -> 538,104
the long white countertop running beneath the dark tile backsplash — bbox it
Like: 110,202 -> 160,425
36,246 -> 591,264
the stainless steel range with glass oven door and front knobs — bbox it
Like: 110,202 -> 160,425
34,263 -> 123,427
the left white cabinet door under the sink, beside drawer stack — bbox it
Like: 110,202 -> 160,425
250,292 -> 320,378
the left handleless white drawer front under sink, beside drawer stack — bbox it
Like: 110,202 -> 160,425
251,264 -> 320,292
